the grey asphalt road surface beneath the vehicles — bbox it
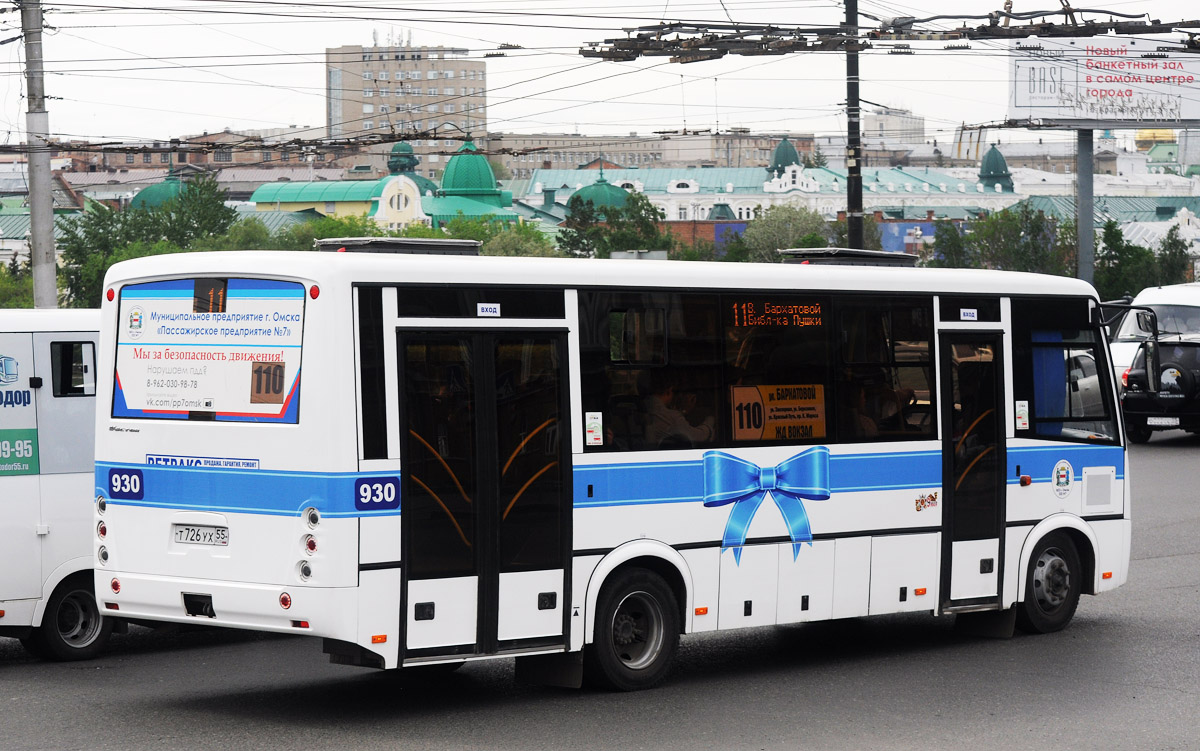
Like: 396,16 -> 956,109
0,433 -> 1200,751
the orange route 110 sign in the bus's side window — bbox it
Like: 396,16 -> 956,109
730,384 -> 826,441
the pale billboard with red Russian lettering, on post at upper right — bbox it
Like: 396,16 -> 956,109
1008,36 -> 1200,127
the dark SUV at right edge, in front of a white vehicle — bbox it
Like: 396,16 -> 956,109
1121,334 -> 1200,443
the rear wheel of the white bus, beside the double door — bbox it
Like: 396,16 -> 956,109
583,569 -> 679,691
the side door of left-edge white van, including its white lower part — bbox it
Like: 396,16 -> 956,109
0,326 -> 41,600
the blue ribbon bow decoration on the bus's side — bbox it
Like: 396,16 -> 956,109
704,446 -> 829,565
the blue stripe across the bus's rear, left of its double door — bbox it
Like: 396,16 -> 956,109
96,462 -> 400,518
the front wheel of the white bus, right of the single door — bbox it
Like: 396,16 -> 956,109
1016,533 -> 1084,633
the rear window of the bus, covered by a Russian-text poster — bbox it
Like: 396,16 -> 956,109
113,277 -> 305,423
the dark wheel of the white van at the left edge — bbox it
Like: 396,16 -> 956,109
25,572 -> 113,662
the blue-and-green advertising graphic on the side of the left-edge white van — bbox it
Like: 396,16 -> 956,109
0,334 -> 38,477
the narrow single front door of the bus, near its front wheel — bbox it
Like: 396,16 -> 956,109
940,331 -> 1006,611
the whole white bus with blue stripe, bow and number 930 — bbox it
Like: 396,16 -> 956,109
95,252 -> 1130,689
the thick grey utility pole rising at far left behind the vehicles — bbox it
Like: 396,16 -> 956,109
17,0 -> 59,307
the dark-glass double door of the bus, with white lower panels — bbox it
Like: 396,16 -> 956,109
397,329 -> 571,659
